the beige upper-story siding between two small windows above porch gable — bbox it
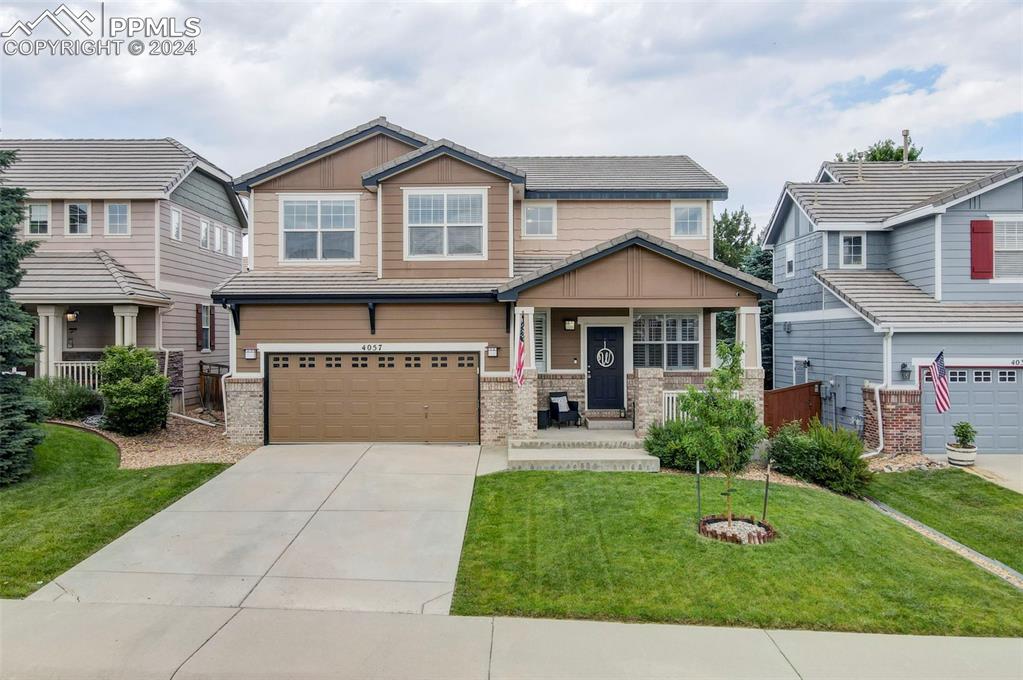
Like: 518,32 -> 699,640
515,200 -> 713,257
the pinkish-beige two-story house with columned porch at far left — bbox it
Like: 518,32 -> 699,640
6,138 -> 247,406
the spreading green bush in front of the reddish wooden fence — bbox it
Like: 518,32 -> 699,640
767,418 -> 872,496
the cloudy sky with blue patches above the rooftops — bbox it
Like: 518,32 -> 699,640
0,1 -> 1023,224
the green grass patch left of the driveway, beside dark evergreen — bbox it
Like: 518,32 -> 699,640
0,425 -> 226,597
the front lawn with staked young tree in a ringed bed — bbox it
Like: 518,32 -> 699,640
452,472 -> 1023,636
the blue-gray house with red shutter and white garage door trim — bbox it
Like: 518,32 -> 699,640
763,161 -> 1023,453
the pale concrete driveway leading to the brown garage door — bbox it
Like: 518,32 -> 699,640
31,444 -> 480,614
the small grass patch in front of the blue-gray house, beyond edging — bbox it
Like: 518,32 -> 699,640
868,468 -> 1023,572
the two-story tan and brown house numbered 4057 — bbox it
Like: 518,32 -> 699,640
214,118 -> 776,443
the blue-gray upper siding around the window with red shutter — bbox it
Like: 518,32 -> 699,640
941,179 -> 1023,303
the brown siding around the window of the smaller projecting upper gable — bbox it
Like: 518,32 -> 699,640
382,156 -> 512,278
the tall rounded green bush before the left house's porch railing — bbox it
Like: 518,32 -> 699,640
99,347 -> 171,435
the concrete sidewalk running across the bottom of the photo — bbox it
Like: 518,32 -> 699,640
0,600 -> 1023,680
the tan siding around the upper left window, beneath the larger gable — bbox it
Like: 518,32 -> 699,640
251,135 -> 412,271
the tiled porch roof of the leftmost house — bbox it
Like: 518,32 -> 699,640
11,250 -> 171,306
